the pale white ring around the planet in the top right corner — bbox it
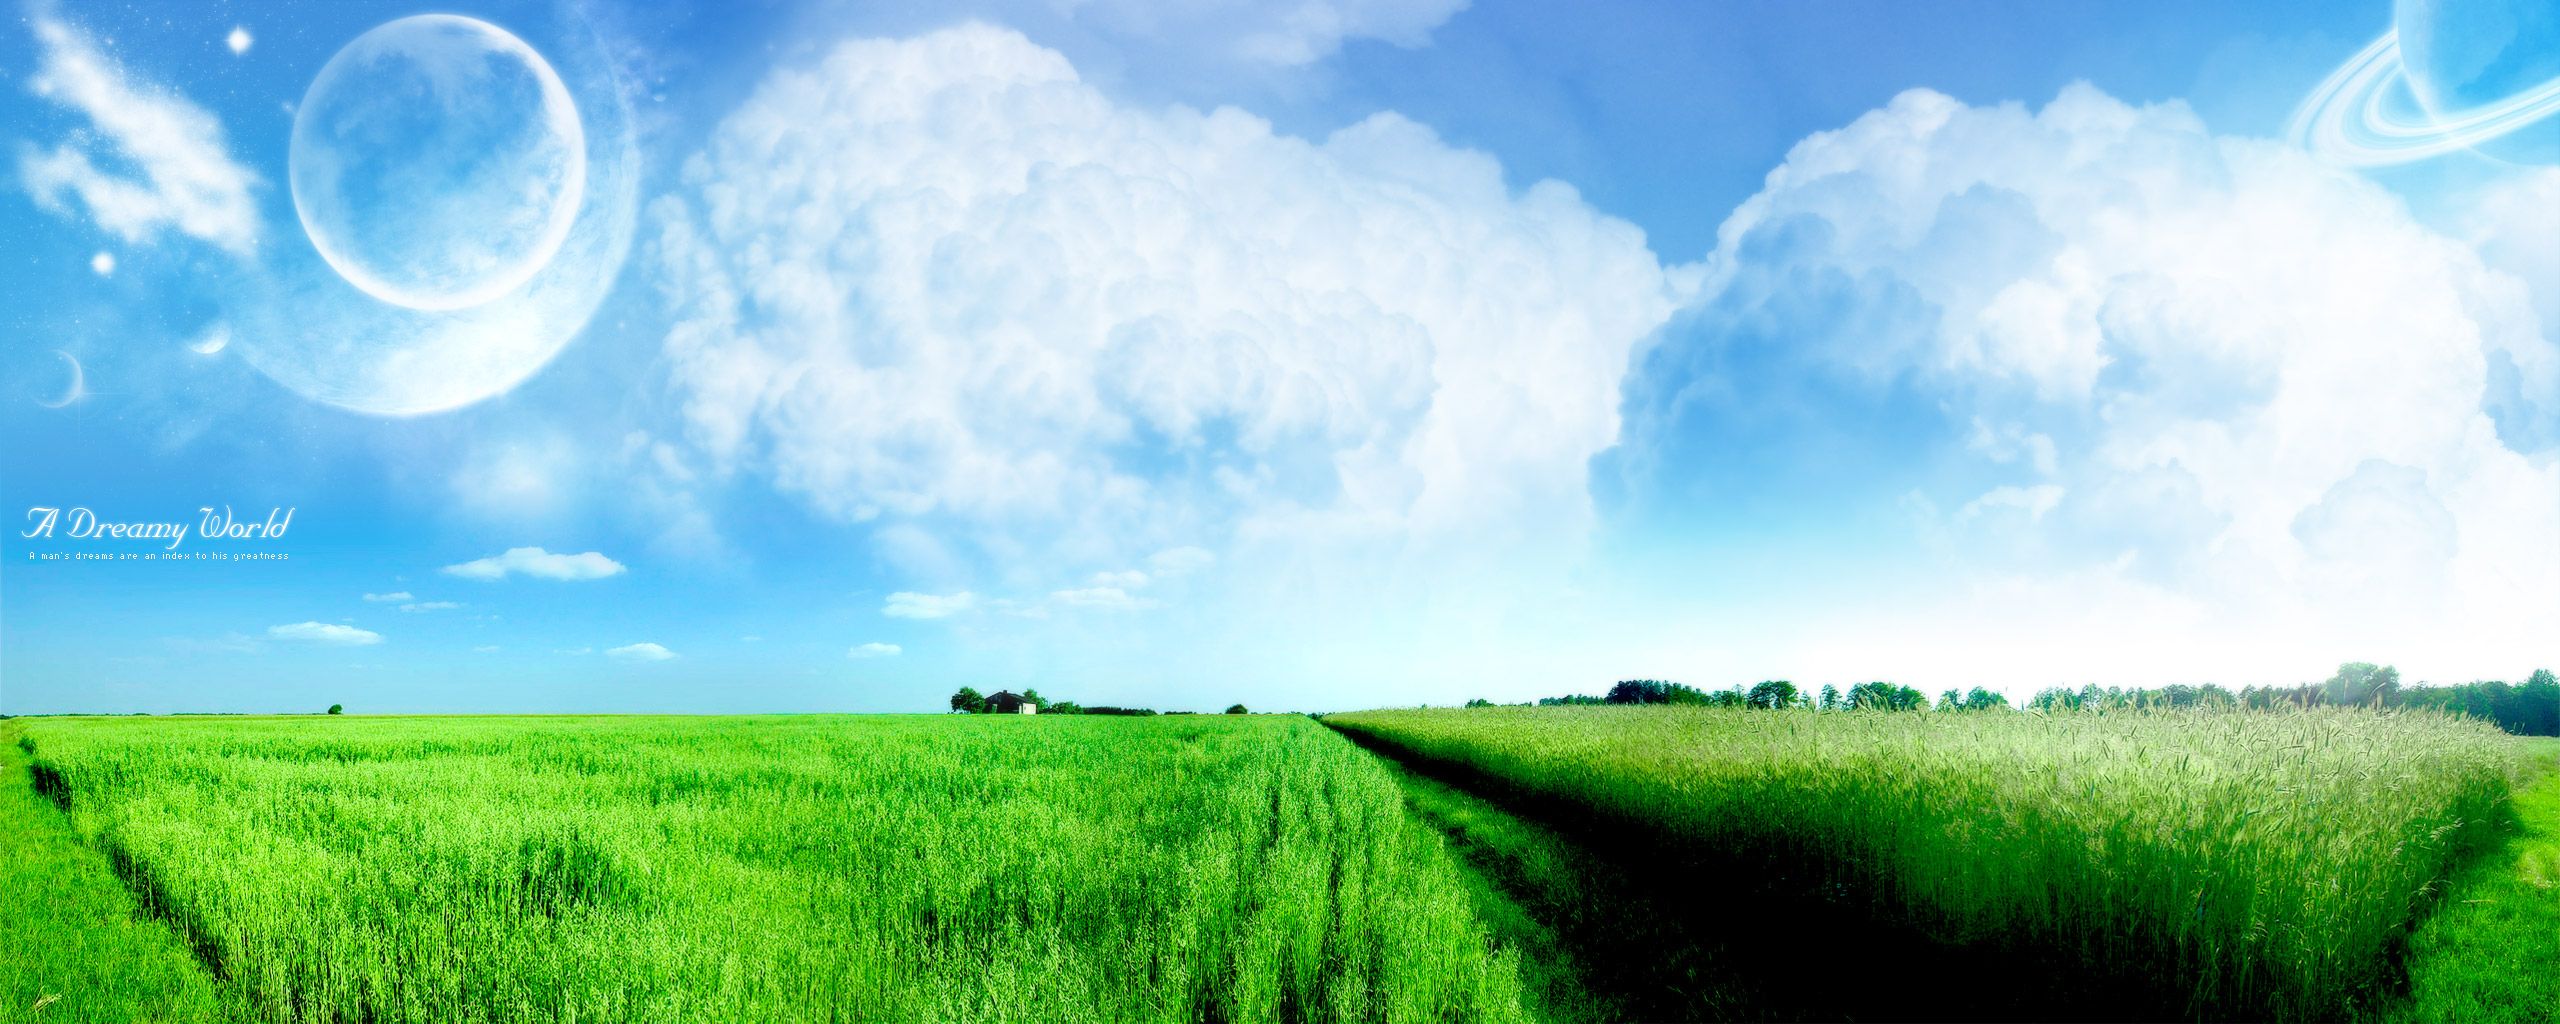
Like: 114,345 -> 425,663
2289,31 -> 2560,166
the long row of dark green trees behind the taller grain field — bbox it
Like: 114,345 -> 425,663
1467,660 -> 2560,735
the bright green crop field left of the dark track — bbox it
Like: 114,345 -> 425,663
0,717 -> 1523,1021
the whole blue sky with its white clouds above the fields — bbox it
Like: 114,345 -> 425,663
0,0 -> 2560,712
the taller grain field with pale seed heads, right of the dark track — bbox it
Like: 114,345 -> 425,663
1326,707 -> 2514,1019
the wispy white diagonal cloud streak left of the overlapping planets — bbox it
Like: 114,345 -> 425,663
18,15 -> 259,256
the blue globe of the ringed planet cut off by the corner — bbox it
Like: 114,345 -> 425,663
2391,0 -> 2560,164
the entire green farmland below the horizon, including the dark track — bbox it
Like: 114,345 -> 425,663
0,707 -> 2560,1021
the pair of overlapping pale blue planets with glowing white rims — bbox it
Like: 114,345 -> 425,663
232,13 -> 640,417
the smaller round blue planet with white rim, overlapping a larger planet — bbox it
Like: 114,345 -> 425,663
289,15 -> 586,310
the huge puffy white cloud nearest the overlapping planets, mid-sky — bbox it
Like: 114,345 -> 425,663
653,26 -> 1674,568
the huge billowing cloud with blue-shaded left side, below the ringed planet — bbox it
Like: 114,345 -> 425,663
1610,84 -> 2560,673
